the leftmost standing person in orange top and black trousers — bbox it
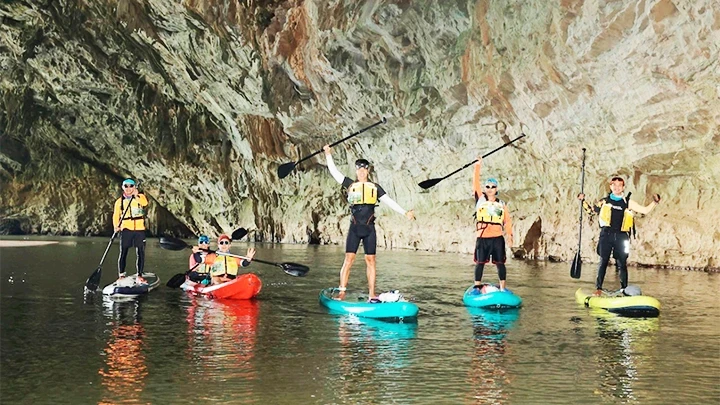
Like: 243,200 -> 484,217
113,179 -> 148,283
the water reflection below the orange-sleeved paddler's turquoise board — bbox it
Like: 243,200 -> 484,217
467,307 -> 520,404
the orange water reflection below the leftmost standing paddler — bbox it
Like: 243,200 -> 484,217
98,298 -> 148,404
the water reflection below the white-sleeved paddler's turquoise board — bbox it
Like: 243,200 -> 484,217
335,315 -> 418,402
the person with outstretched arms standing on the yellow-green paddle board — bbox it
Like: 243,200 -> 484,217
578,176 -> 660,296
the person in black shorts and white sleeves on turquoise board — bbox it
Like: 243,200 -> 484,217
323,145 -> 415,300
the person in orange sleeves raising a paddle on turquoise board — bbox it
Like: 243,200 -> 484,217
473,157 -> 513,291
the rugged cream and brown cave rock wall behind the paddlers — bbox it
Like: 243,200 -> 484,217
0,0 -> 720,268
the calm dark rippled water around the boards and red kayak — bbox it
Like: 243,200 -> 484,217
0,237 -> 720,404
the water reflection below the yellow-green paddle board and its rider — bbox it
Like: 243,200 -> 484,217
591,310 -> 660,403
